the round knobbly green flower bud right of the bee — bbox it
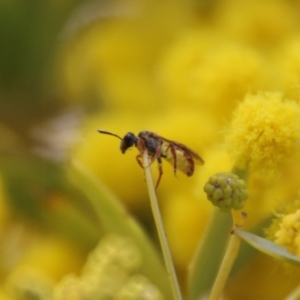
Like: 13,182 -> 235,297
204,172 -> 248,212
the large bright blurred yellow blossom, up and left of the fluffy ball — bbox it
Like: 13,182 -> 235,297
159,29 -> 269,122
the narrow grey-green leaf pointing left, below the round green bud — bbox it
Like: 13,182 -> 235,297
234,229 -> 300,265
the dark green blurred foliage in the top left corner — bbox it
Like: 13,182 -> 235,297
0,0 -> 79,134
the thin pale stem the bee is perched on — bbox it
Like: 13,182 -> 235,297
143,151 -> 182,300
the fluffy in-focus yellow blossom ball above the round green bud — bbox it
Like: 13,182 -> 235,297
227,92 -> 300,174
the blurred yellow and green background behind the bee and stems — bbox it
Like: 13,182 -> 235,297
0,0 -> 300,300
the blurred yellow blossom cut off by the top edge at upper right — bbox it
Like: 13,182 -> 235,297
215,0 -> 298,47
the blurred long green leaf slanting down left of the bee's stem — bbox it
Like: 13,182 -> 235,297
68,162 -> 172,299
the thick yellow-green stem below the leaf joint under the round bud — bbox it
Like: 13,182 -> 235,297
209,224 -> 241,300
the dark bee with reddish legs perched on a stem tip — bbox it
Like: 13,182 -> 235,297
98,129 -> 204,188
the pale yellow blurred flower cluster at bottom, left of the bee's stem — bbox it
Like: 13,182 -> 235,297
54,235 -> 164,300
